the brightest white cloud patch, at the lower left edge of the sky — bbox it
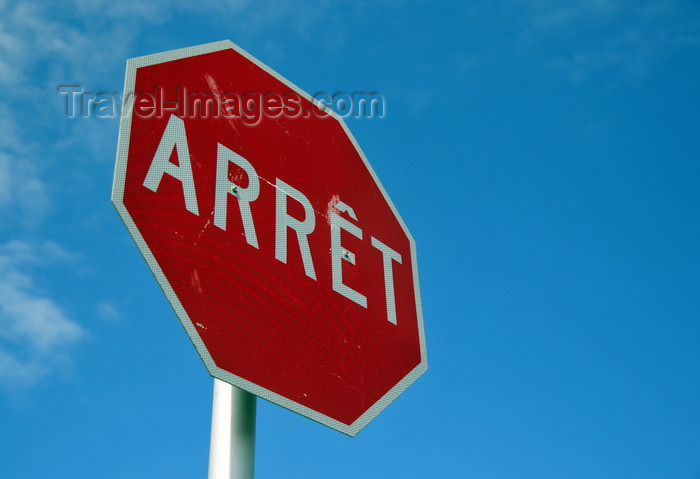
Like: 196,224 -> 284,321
0,241 -> 86,387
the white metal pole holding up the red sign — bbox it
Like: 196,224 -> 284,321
209,378 -> 256,479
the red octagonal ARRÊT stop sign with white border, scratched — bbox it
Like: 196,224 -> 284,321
112,41 -> 427,435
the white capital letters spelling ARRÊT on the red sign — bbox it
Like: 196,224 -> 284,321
140,124 -> 402,324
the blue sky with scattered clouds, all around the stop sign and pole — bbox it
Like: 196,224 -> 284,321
0,0 -> 700,479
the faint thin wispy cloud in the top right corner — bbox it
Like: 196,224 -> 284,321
518,0 -> 700,80
